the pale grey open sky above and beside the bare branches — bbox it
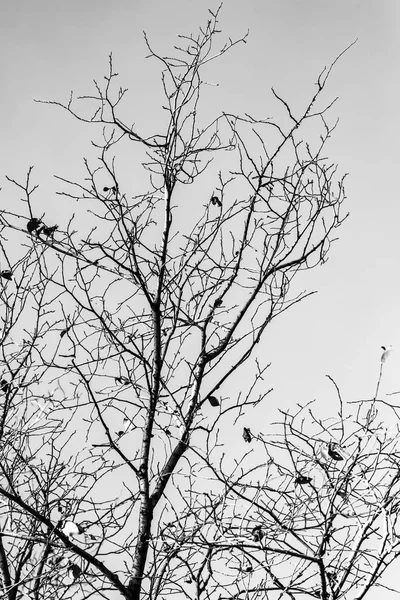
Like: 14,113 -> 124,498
0,0 -> 400,596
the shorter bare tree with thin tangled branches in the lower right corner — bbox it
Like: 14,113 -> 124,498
181,384 -> 400,600
